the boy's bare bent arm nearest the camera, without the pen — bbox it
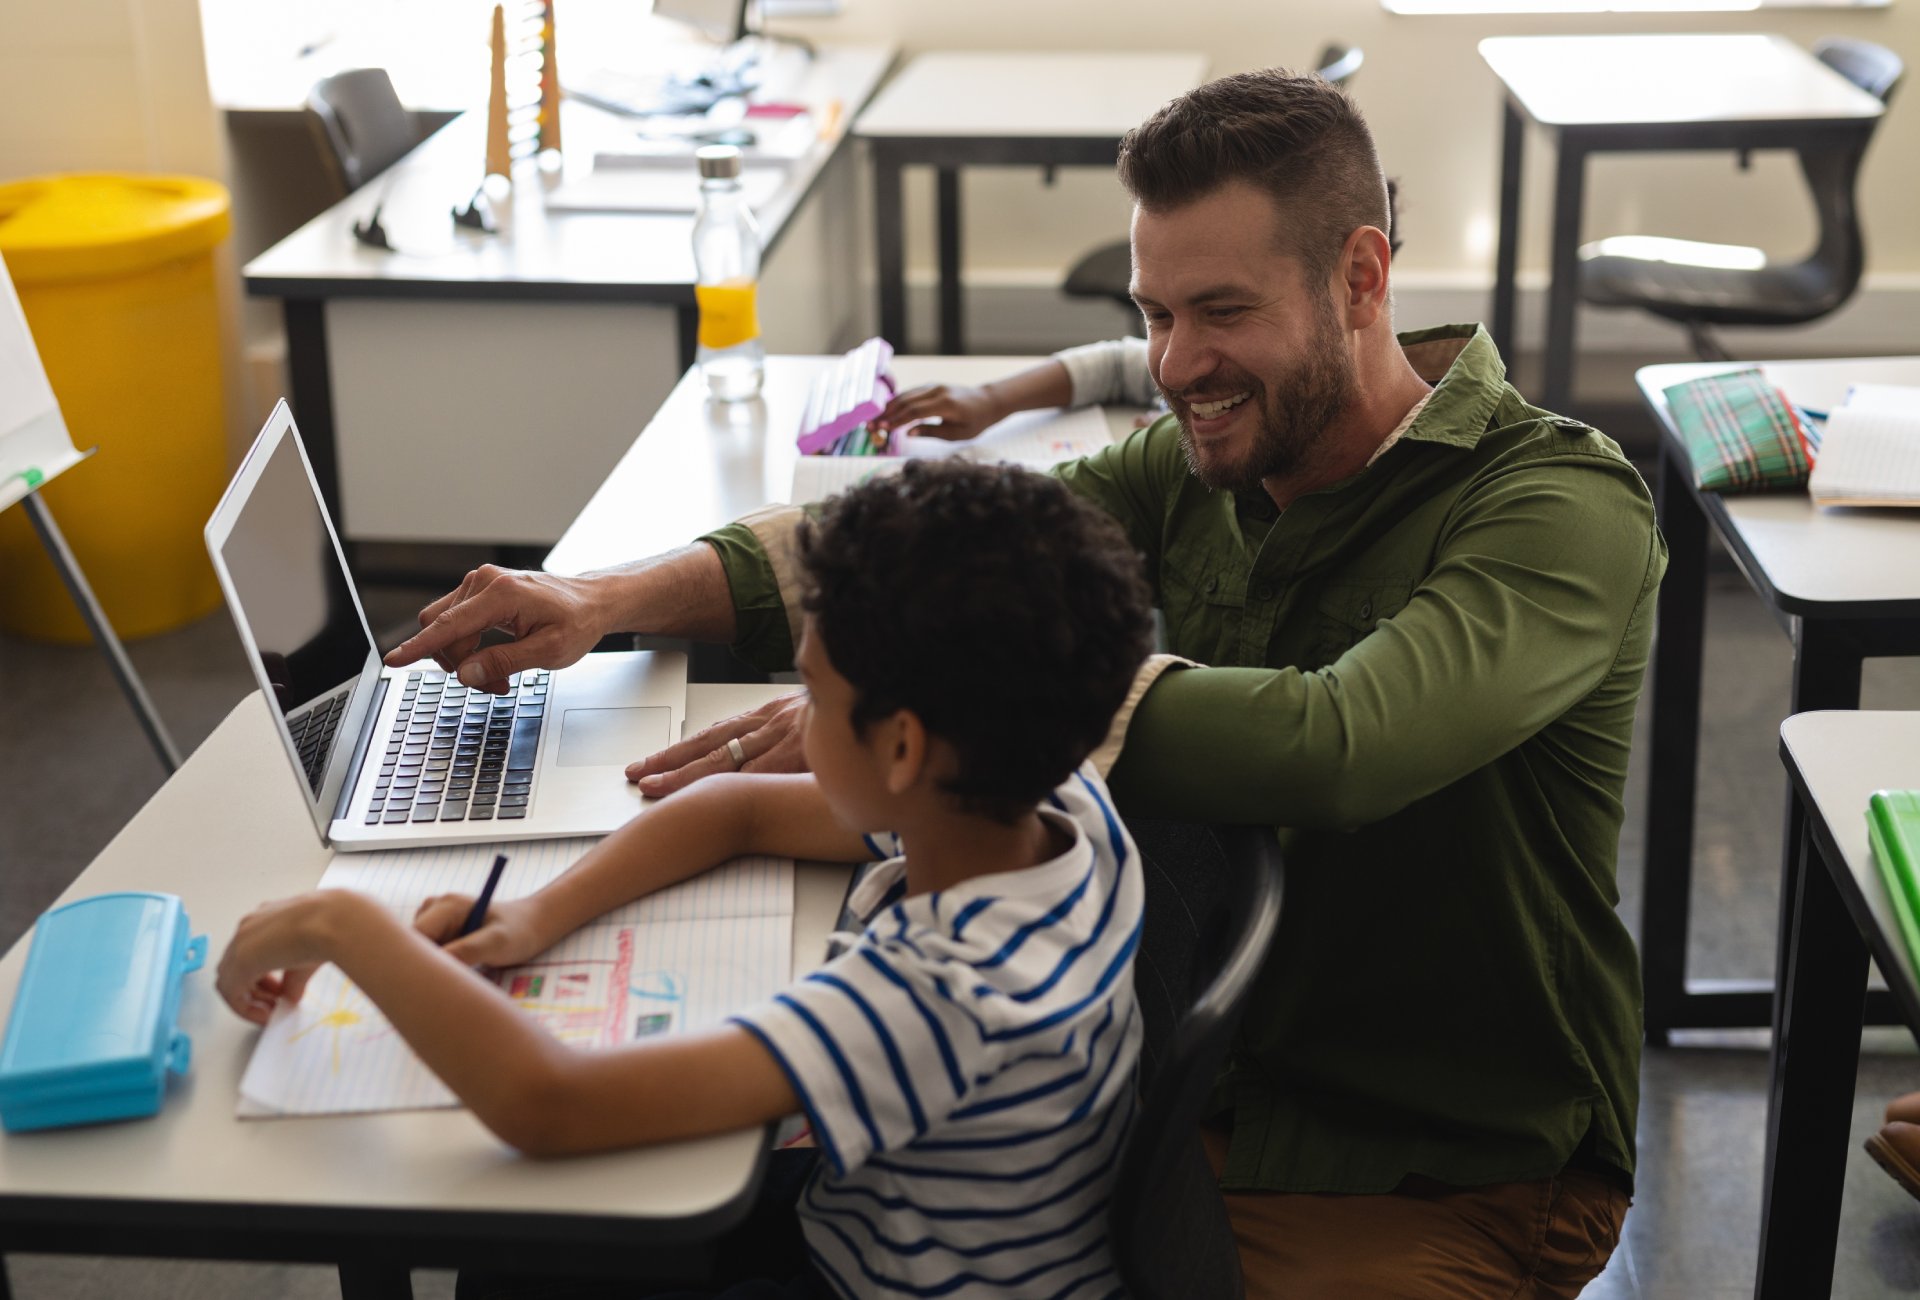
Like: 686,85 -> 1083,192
219,891 -> 799,1156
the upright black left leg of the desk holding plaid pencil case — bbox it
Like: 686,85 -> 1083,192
1640,440 -> 1707,1045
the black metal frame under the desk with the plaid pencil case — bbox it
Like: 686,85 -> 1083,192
1640,430 -> 1920,1043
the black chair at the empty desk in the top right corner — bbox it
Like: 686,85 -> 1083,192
1580,36 -> 1907,361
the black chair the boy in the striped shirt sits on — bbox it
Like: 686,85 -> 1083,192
1108,822 -> 1281,1300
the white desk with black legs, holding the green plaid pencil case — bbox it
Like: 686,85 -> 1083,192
1636,357 -> 1920,1043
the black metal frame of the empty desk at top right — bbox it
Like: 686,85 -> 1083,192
1492,101 -> 1878,411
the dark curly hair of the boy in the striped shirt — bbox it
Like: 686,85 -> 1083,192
801,461 -> 1152,822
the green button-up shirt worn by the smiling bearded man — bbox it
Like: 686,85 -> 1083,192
708,326 -> 1667,1192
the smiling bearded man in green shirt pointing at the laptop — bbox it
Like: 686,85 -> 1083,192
394,73 -> 1665,1300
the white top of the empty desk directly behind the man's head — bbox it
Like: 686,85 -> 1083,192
856,50 -> 1206,140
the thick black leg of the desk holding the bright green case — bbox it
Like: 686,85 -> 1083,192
1753,818 -> 1866,1300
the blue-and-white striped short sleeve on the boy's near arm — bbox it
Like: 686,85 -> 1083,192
733,927 -> 1006,1175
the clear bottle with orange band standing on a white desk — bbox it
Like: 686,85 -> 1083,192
693,144 -> 766,401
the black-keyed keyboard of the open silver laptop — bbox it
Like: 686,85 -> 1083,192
367,668 -> 553,826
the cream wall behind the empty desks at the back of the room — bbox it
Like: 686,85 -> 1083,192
783,0 -> 1920,346
